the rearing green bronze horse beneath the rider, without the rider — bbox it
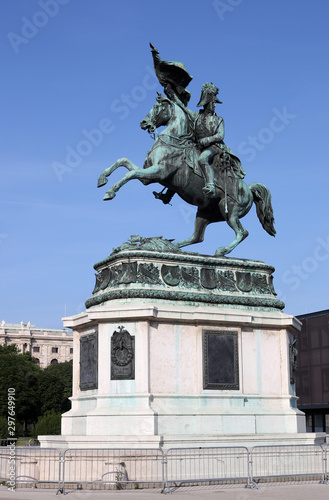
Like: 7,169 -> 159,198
98,94 -> 276,255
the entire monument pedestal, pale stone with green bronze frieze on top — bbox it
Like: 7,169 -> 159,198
41,238 -> 305,447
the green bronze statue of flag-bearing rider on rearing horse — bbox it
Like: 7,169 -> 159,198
98,45 -> 275,256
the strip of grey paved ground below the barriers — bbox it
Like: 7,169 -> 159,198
0,483 -> 329,500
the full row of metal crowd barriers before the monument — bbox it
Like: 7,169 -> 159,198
0,441 -> 329,494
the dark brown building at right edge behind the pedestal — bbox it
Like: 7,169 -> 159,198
295,309 -> 329,434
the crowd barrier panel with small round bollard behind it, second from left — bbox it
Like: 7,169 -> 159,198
60,448 -> 164,494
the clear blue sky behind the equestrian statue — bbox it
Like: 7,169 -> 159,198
0,0 -> 329,328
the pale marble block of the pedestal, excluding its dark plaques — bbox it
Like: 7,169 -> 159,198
50,303 -> 305,442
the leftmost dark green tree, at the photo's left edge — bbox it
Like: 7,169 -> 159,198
0,345 -> 41,430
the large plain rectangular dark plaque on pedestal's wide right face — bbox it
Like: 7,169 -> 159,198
203,330 -> 239,390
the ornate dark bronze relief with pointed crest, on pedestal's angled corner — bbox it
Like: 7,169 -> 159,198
111,326 -> 135,380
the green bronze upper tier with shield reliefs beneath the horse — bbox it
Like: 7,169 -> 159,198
86,235 -> 284,310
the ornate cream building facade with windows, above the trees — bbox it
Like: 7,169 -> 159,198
0,321 -> 73,368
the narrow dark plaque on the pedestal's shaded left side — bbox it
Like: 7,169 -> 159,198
80,332 -> 98,391
